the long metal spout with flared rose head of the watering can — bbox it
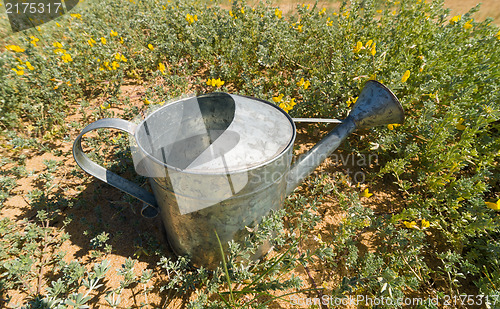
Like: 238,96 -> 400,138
286,80 -> 404,195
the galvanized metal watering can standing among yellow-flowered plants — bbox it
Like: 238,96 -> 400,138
73,80 -> 404,268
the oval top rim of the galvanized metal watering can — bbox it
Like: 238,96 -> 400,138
133,91 -> 297,176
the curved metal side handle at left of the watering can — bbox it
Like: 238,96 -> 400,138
73,118 -> 159,218
